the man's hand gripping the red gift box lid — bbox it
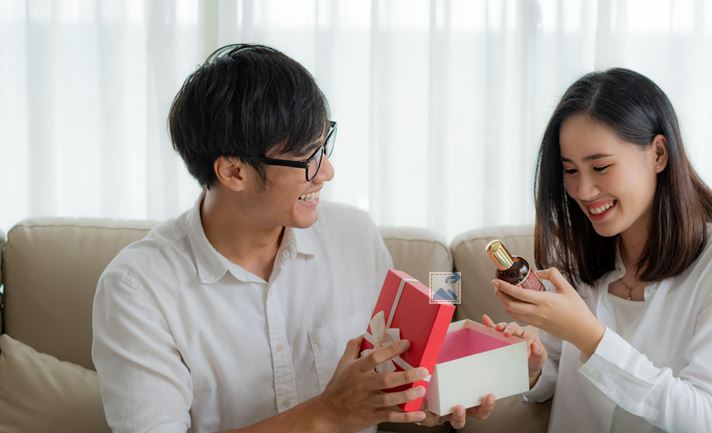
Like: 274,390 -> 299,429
317,337 -> 428,433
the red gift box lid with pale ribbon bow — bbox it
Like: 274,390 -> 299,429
361,269 -> 455,412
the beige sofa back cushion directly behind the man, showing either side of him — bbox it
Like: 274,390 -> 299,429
0,218 -> 452,368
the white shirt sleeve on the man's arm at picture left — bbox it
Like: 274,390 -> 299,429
92,273 -> 193,433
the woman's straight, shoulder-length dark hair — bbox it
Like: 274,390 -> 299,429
534,68 -> 712,285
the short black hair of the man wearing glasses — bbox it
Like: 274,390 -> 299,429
168,44 -> 329,189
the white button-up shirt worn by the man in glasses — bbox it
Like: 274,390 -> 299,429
92,199 -> 391,433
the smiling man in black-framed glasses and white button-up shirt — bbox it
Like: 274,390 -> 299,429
92,45 -> 490,433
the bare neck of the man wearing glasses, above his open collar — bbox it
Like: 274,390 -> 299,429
200,191 -> 284,281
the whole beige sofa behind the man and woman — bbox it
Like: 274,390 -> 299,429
0,218 -> 549,433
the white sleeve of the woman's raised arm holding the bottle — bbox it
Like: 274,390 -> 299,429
579,296 -> 712,432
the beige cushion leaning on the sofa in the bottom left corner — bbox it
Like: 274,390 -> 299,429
0,334 -> 110,433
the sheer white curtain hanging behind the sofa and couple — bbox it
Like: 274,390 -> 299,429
0,0 -> 712,239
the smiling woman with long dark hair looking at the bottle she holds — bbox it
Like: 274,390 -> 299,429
485,69 -> 712,432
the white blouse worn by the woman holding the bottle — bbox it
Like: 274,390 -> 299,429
524,226 -> 712,433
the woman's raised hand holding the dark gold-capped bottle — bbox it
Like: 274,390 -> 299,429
492,268 -> 605,358
